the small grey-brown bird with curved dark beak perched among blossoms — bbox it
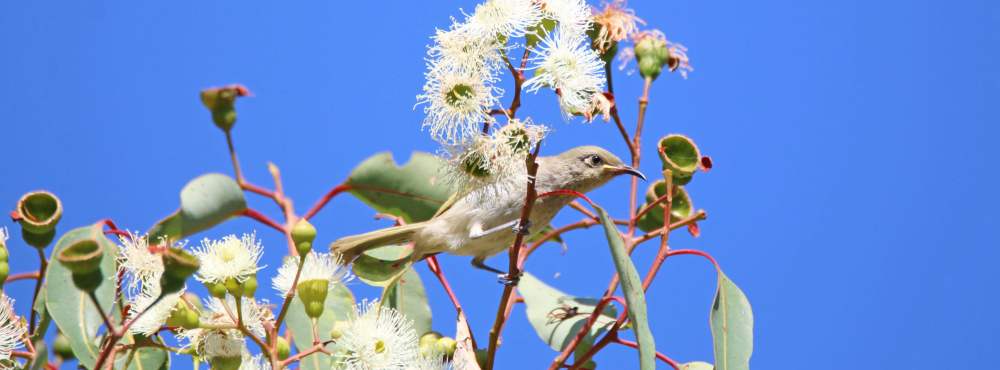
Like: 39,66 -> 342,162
330,145 -> 646,274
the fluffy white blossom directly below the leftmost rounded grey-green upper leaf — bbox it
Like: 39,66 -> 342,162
192,233 -> 264,283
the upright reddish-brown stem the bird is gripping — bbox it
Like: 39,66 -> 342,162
485,142 -> 542,370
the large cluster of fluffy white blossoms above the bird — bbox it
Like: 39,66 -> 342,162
417,0 -> 607,191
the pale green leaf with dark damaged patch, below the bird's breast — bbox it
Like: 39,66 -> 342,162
517,273 -> 617,352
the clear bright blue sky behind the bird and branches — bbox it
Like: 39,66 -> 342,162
0,0 -> 1000,369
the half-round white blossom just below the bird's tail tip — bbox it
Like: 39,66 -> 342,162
271,252 -> 354,297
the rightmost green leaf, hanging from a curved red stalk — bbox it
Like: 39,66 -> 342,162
710,271 -> 753,370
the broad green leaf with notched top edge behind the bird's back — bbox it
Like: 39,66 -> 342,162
347,152 -> 452,223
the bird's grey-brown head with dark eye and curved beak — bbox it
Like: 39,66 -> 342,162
543,145 -> 646,192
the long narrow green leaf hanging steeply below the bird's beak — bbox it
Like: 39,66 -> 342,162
594,206 -> 656,370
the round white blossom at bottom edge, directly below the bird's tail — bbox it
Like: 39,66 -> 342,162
335,300 -> 420,370
